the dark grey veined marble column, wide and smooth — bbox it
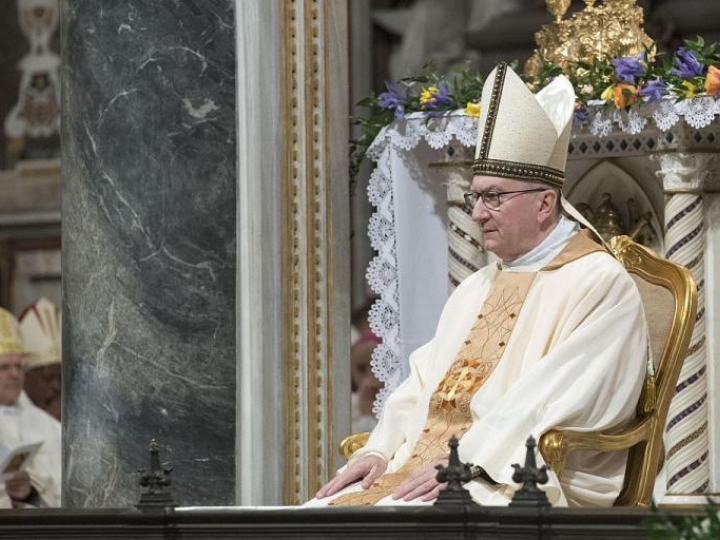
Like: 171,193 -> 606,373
62,0 -> 236,507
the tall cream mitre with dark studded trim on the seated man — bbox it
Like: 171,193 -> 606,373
472,62 -> 575,189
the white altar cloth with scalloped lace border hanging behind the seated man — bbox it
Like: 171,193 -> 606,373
367,97 -> 720,415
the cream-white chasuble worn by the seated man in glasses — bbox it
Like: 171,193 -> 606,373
309,231 -> 647,506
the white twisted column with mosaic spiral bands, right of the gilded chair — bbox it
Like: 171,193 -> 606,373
658,152 -> 720,503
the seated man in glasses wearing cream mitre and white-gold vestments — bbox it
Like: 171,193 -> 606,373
308,64 -> 648,506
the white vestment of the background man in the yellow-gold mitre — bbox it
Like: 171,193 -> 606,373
0,392 -> 62,507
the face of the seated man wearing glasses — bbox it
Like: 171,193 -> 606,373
470,175 -> 542,262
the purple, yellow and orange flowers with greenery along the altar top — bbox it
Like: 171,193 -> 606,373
350,37 -> 720,179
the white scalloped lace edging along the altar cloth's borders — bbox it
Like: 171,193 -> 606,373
366,97 -> 720,415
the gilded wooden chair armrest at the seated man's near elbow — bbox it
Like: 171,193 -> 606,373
538,415 -> 656,477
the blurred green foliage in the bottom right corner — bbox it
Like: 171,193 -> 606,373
643,500 -> 720,540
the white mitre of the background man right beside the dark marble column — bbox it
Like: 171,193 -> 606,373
20,298 -> 62,369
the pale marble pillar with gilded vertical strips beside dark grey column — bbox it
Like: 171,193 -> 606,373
236,0 -> 350,505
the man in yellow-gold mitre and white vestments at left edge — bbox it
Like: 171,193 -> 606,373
0,308 -> 62,508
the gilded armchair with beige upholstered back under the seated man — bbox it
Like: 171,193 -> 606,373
340,236 -> 697,506
